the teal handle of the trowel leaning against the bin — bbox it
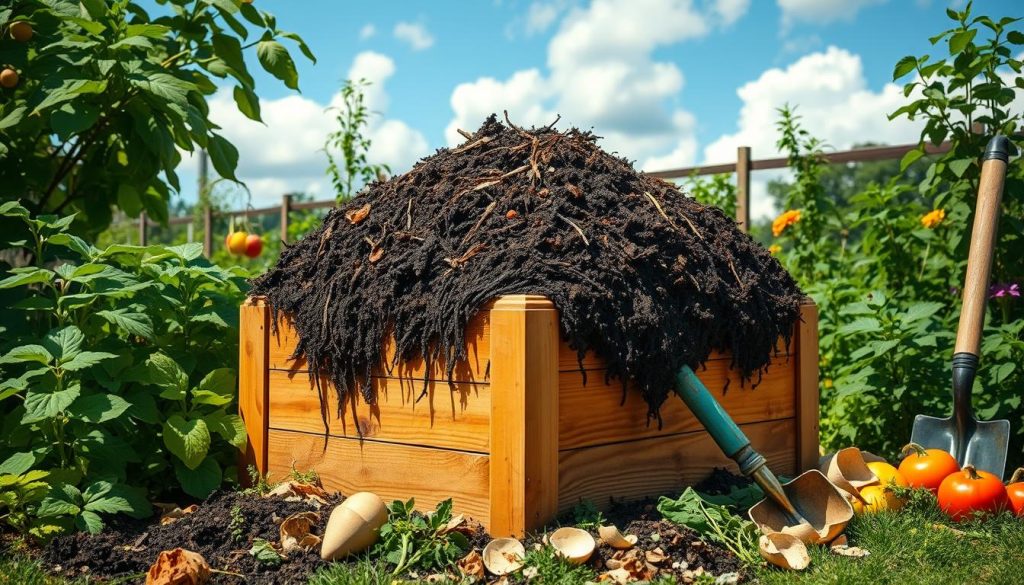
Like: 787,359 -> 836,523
676,366 -> 766,475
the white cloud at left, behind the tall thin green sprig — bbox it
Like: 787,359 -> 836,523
188,51 -> 429,207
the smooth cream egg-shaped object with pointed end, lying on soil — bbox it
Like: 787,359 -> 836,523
321,492 -> 387,560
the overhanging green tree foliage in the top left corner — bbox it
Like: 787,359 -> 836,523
0,0 -> 314,234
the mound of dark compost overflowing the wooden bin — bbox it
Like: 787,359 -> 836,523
252,116 -> 802,417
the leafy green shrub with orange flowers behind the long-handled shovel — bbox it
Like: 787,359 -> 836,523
774,5 -> 1024,464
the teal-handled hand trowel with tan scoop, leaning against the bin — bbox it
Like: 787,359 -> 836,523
675,366 -> 853,542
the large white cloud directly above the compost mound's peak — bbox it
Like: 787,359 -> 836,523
445,0 -> 729,167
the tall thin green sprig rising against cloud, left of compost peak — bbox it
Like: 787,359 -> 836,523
324,80 -> 391,203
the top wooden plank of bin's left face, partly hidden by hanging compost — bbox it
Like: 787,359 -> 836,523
270,308 -> 490,383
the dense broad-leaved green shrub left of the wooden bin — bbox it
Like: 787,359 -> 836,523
0,202 -> 245,537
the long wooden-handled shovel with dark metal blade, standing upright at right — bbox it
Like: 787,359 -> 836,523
910,136 -> 1011,477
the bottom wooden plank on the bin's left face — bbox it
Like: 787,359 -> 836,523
269,430 -> 489,526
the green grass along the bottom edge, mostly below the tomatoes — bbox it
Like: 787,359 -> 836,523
0,501 -> 1024,585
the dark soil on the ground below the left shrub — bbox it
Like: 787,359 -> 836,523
42,492 -> 341,585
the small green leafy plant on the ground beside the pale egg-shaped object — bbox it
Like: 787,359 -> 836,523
373,499 -> 469,576
